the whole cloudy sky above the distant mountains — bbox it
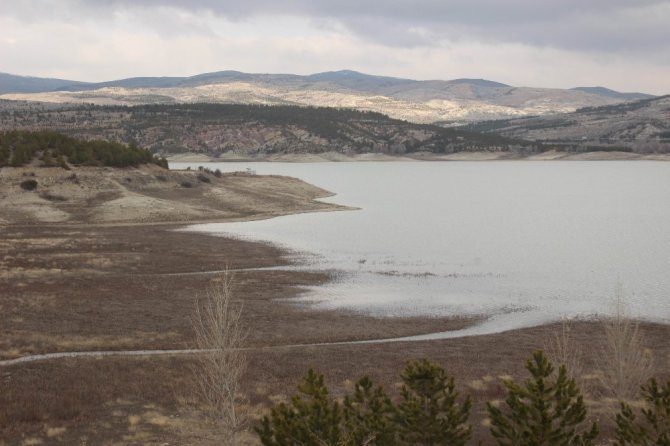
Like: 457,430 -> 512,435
0,0 -> 670,94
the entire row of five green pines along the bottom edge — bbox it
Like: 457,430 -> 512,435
255,350 -> 670,446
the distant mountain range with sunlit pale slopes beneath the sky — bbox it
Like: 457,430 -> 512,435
0,70 -> 653,124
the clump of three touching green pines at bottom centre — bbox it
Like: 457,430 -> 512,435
255,359 -> 472,446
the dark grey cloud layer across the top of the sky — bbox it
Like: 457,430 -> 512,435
5,0 -> 670,52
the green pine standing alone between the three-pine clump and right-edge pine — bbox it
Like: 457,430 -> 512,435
487,351 -> 598,446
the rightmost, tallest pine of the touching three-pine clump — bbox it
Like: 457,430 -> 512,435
396,359 -> 472,446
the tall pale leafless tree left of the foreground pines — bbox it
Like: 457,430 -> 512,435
192,271 -> 247,446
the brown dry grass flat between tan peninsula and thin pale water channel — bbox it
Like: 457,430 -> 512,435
0,226 -> 472,358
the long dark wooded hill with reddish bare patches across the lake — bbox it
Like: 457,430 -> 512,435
0,101 -> 537,156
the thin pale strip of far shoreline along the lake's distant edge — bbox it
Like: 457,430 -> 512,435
167,150 -> 670,163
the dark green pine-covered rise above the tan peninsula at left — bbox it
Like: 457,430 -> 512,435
0,130 -> 167,168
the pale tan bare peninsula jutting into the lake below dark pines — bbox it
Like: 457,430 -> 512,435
0,166 -> 346,224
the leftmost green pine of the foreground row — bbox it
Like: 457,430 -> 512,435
254,368 -> 342,446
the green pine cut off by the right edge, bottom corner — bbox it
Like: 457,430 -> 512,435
616,379 -> 670,446
